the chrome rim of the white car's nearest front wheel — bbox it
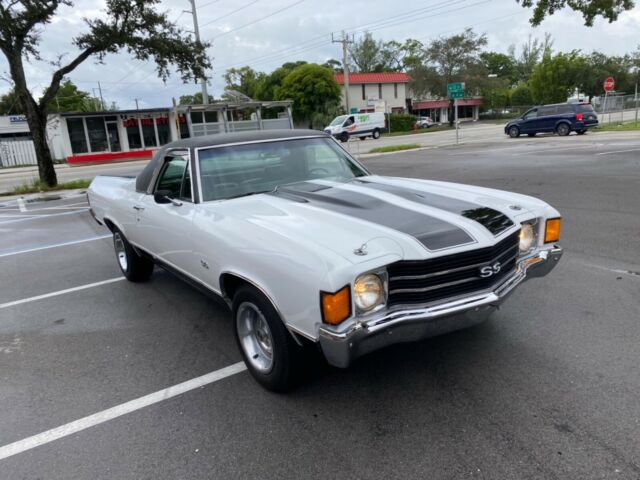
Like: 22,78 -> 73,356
236,302 -> 273,373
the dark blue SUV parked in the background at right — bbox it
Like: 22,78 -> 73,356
504,103 -> 598,138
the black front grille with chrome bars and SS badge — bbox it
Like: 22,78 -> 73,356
387,231 -> 520,306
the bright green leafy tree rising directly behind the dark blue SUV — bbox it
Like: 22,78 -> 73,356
529,50 -> 584,104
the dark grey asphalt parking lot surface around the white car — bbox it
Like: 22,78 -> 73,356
0,134 -> 640,480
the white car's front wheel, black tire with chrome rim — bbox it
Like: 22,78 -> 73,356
232,285 -> 303,392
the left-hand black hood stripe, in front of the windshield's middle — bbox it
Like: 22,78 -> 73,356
270,182 -> 475,250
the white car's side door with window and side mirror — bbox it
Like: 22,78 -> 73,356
136,150 -> 197,274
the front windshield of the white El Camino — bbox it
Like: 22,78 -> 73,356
198,138 -> 368,202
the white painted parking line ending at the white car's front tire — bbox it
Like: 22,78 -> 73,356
0,362 -> 247,460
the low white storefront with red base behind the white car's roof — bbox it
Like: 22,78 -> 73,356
48,101 -> 293,164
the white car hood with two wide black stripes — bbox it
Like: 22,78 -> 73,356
203,176 -> 550,263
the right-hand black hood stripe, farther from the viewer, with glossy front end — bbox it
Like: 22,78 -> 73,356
352,180 -> 514,235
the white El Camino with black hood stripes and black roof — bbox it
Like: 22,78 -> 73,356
88,130 -> 562,390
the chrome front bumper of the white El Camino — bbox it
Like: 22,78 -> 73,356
320,246 -> 562,368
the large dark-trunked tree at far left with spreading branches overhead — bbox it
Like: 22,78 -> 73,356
0,0 -> 211,186
